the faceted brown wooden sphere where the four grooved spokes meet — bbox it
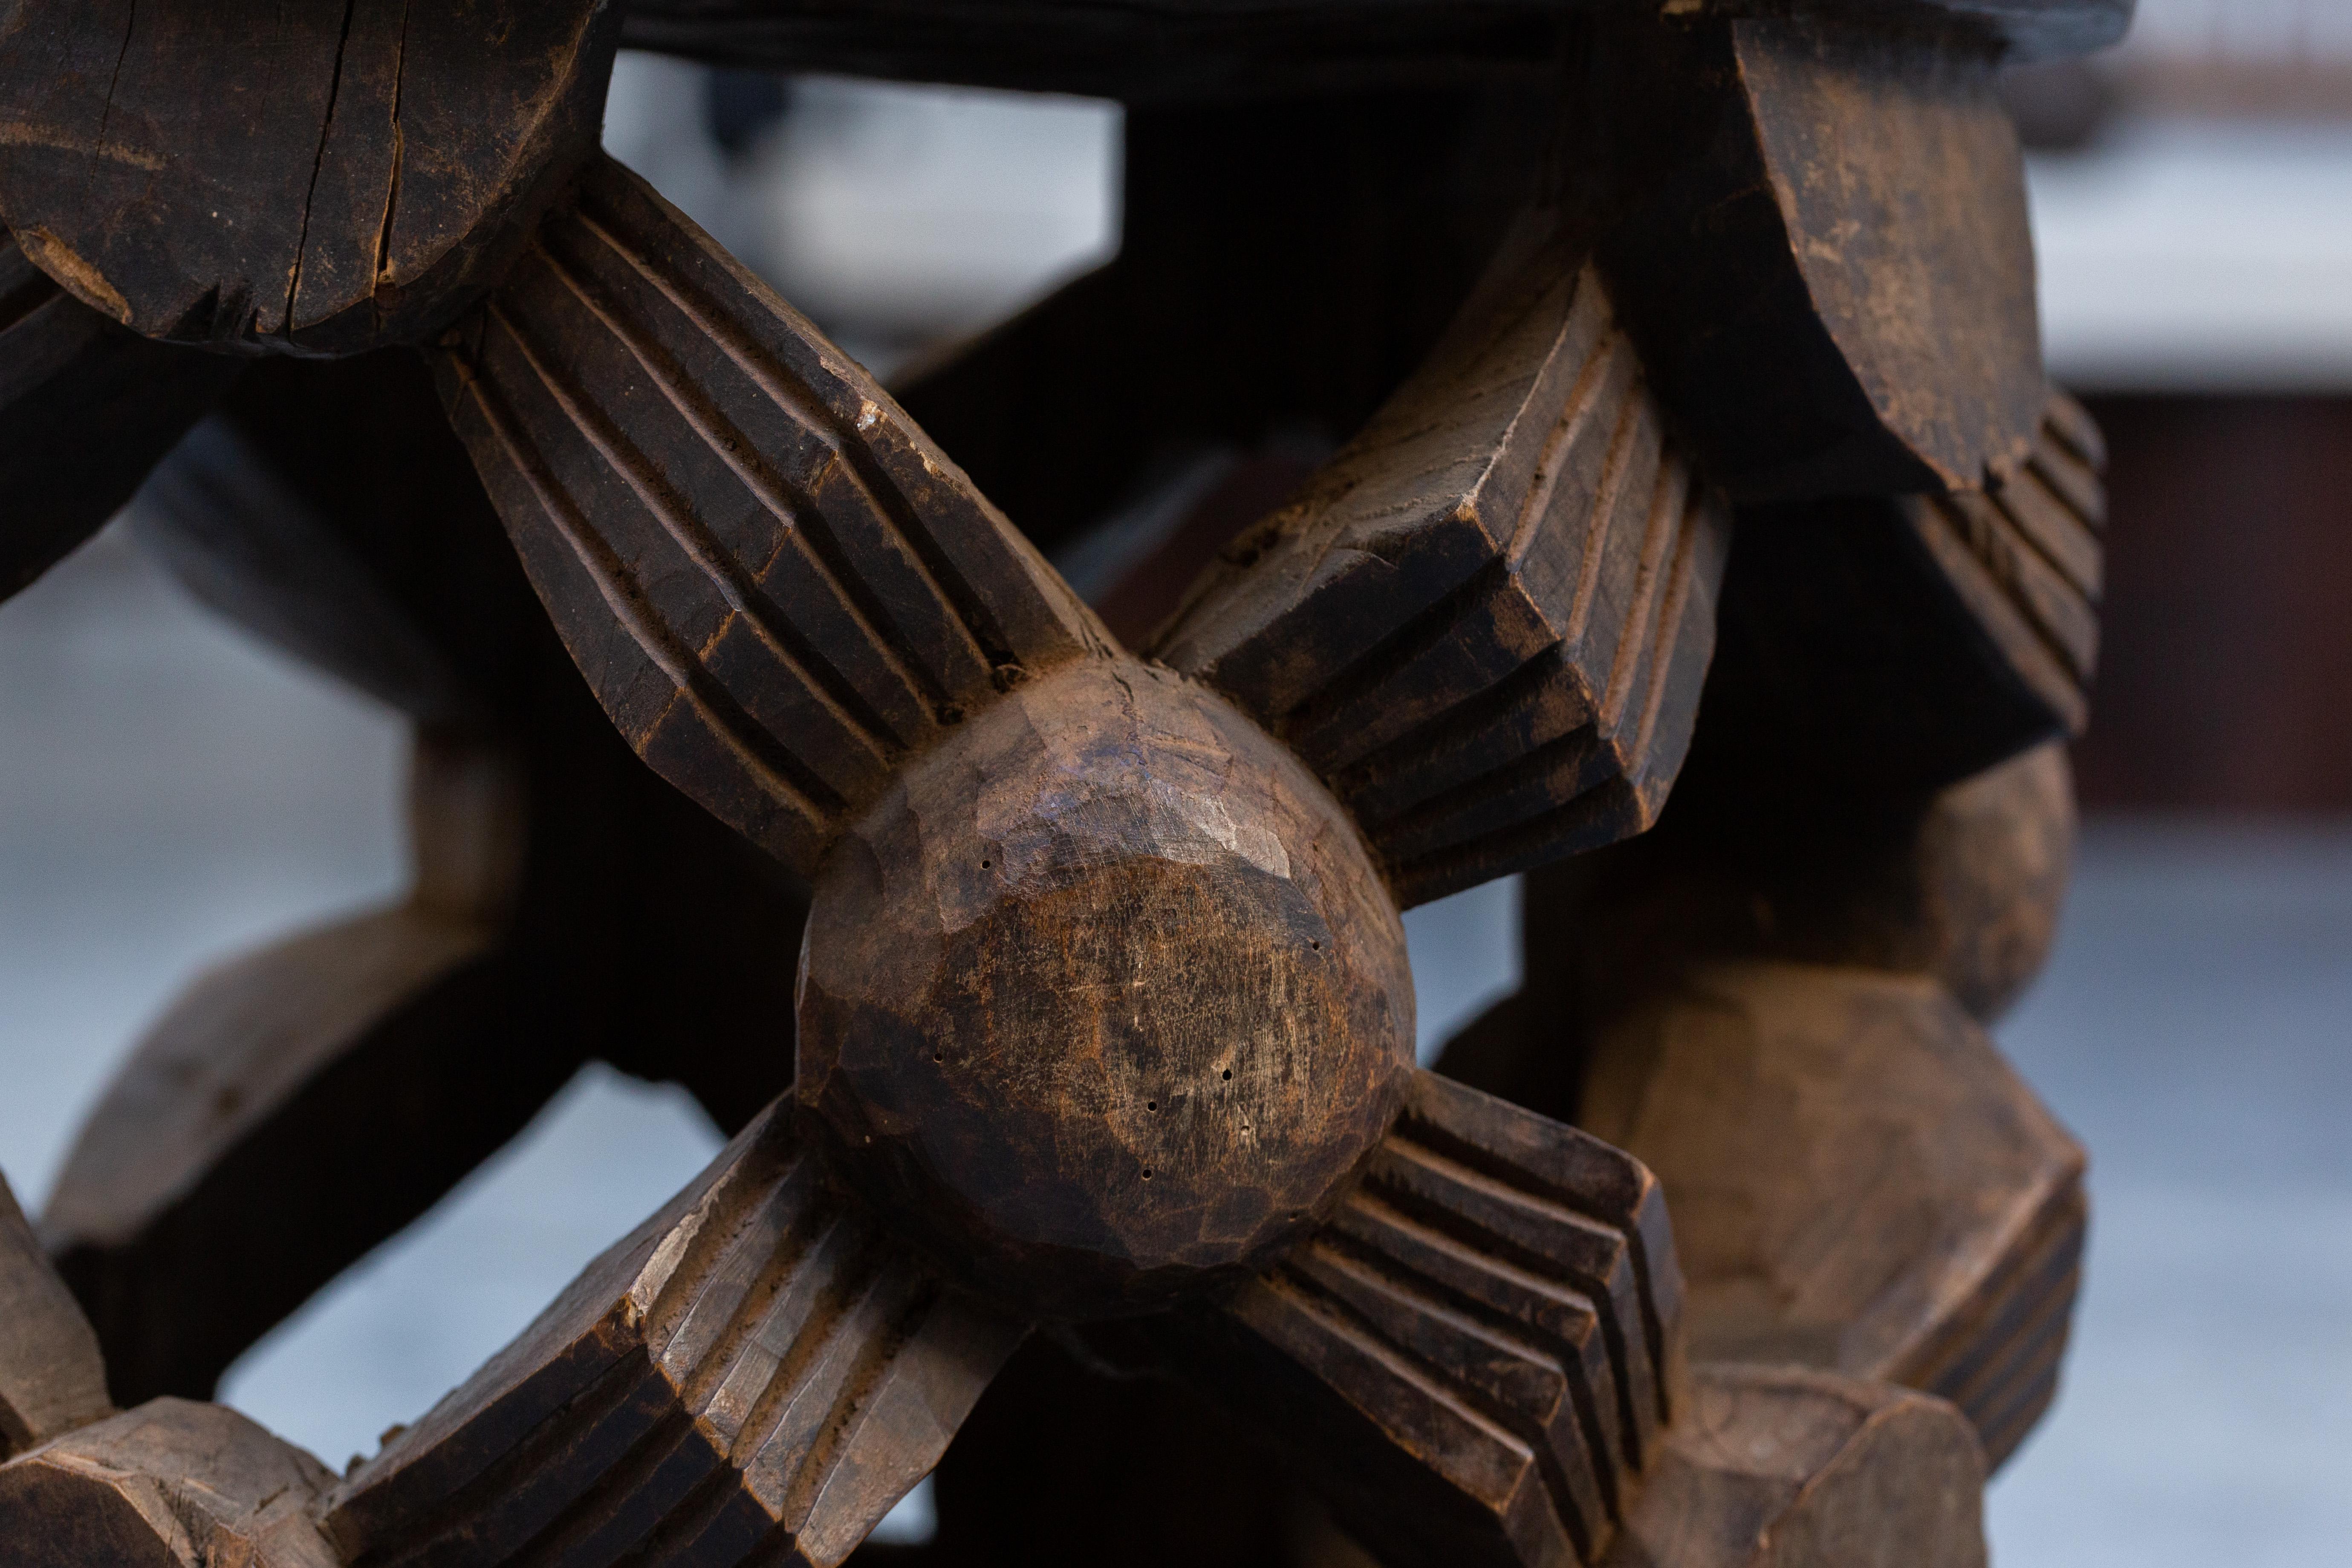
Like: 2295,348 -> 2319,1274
800,661 -> 1413,1319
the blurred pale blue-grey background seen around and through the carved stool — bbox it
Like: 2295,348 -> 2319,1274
0,0 -> 2352,1568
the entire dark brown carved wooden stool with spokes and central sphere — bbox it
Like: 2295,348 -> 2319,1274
0,0 -> 2129,1568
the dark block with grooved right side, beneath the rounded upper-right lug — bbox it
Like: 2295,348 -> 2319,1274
1689,393 -> 2105,809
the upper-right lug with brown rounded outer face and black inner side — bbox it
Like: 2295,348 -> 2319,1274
1578,14 -> 2044,501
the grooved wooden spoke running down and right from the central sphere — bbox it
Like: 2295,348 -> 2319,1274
1159,1074 -> 1684,1565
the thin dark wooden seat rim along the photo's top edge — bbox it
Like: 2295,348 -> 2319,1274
626,0 -> 2131,101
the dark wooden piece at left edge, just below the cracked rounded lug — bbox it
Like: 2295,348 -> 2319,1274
0,233 -> 237,600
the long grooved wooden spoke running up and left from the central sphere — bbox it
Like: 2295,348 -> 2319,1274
440,160 -> 1101,872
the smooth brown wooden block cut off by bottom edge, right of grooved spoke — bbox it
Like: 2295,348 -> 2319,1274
1607,1366 -> 1985,1568
